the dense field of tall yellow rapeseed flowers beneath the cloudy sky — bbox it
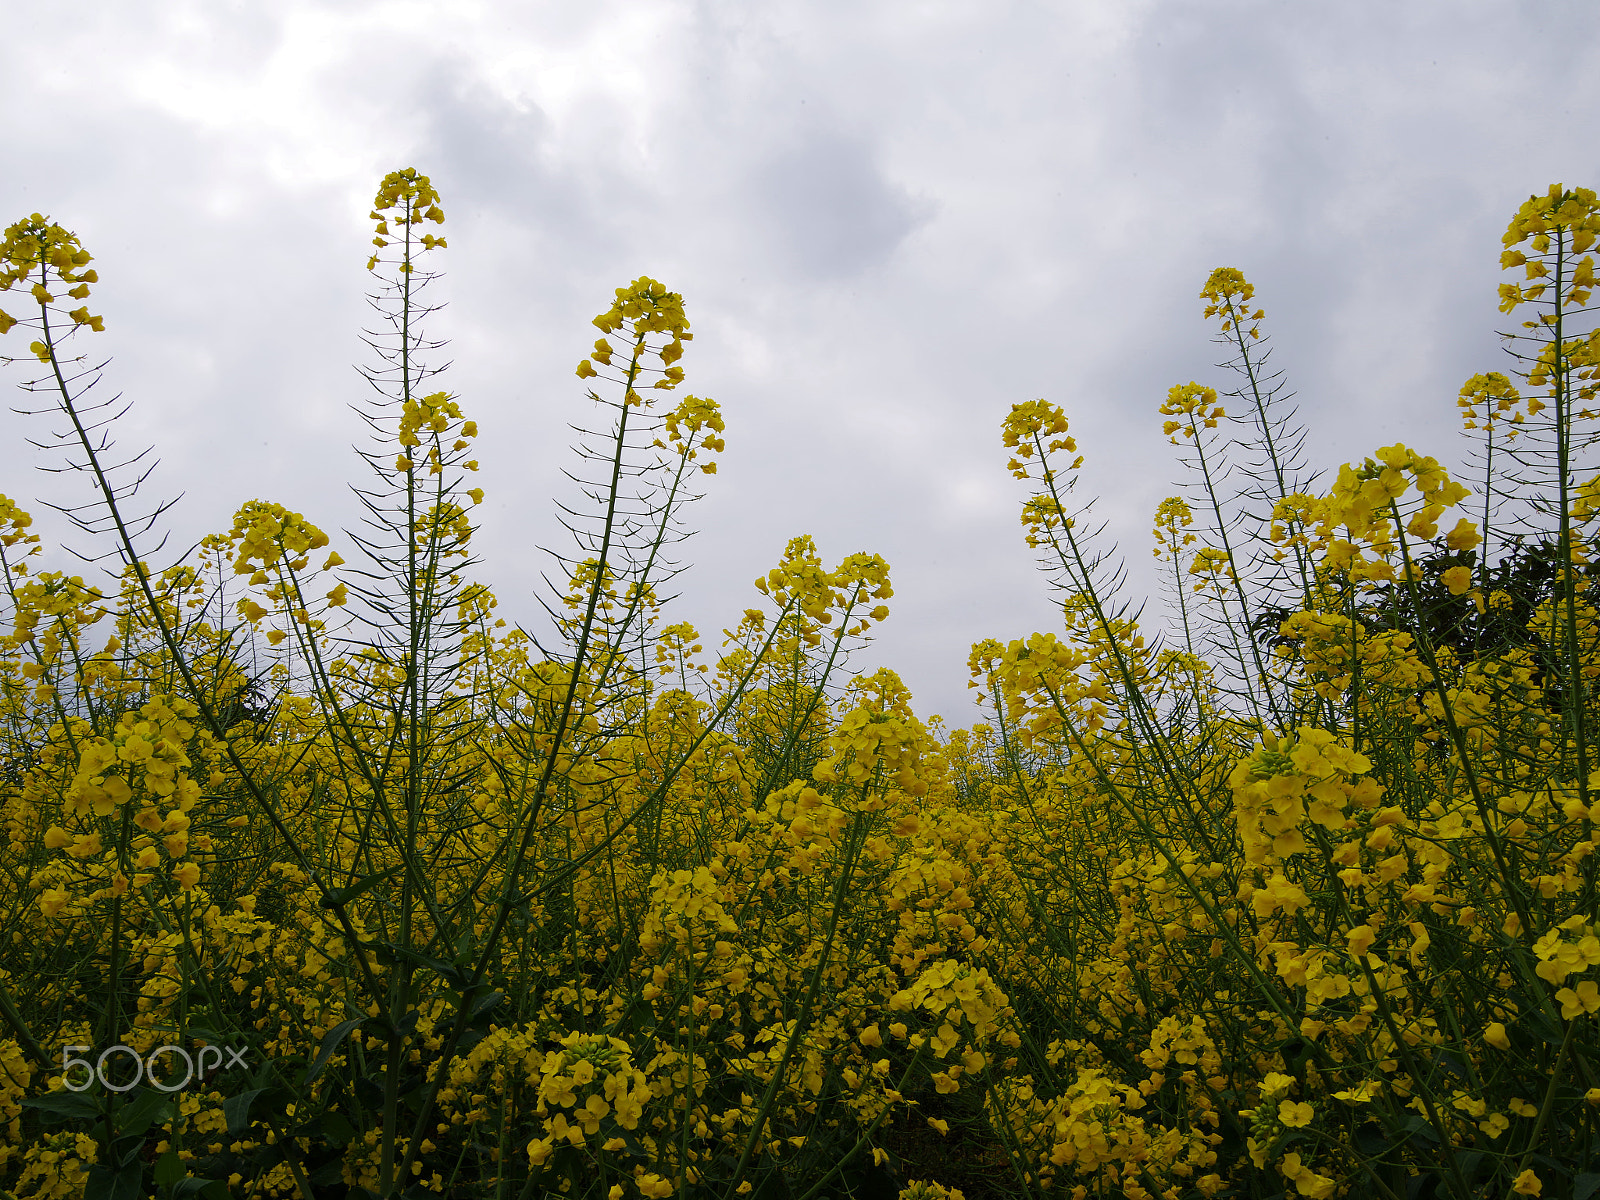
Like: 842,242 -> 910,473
0,171 -> 1600,1200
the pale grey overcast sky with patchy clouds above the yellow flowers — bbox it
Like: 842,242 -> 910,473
0,0 -> 1600,725
